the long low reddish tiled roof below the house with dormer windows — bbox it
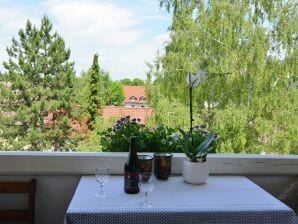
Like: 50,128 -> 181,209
102,106 -> 153,124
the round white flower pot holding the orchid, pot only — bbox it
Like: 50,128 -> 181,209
182,160 -> 209,184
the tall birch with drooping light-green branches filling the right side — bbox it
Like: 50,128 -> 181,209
147,0 -> 298,154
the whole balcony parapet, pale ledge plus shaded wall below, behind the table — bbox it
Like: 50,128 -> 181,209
0,152 -> 298,224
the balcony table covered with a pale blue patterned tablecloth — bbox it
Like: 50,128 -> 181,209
64,176 -> 295,224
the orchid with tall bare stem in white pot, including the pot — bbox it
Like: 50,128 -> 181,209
179,71 -> 217,184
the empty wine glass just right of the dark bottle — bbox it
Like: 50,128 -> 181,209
139,172 -> 154,208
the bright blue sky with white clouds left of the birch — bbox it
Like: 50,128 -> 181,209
0,0 -> 171,80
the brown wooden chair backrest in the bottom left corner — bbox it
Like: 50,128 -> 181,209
0,179 -> 36,224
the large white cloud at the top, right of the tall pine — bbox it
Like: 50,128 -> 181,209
45,0 -> 141,47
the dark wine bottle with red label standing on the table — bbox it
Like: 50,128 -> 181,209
124,136 -> 140,194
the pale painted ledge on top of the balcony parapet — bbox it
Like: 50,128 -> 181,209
0,151 -> 298,176
